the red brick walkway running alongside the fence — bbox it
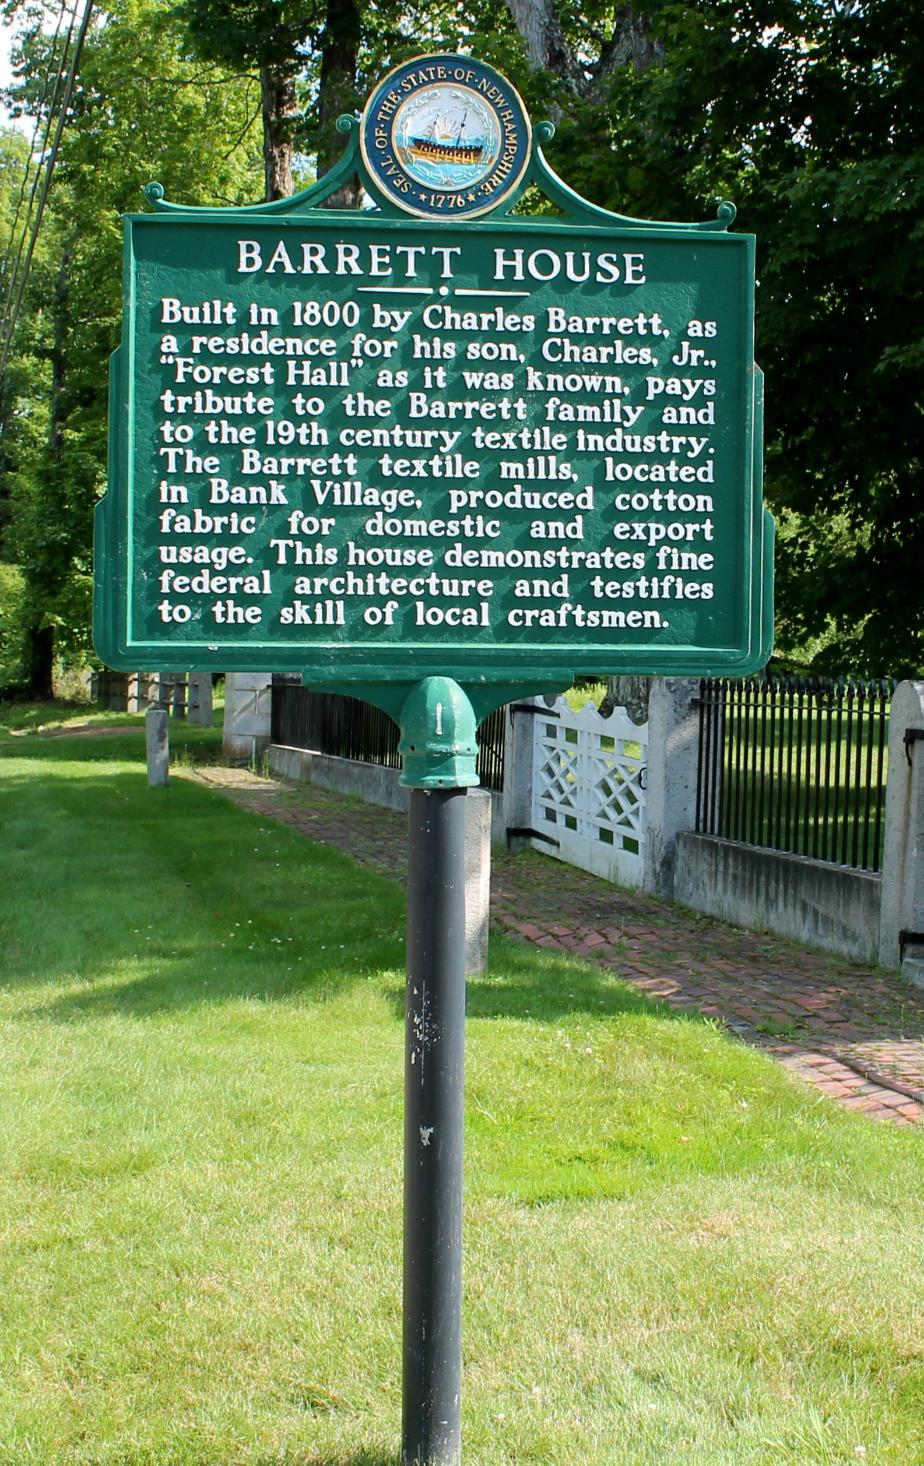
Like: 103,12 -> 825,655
183,767 -> 924,1124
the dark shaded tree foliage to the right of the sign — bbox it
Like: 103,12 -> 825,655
536,0 -> 924,674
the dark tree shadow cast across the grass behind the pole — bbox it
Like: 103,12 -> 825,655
0,739 -> 712,1022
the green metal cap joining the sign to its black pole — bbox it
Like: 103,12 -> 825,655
397,677 -> 478,789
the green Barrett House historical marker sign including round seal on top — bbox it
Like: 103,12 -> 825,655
95,57 -> 773,683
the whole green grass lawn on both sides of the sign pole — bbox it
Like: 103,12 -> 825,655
0,730 -> 924,1466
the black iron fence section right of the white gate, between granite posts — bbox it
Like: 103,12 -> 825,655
697,677 -> 895,871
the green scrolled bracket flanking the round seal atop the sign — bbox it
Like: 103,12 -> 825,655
144,113 -> 736,233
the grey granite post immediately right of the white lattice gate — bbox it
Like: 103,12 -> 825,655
642,677 -> 700,900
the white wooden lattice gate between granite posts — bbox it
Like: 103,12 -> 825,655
532,698 -> 648,885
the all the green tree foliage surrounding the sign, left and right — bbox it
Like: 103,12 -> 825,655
0,0 -> 924,674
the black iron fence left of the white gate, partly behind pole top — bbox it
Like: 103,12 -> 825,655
271,673 -> 506,790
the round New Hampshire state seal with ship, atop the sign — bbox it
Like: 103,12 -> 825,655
359,56 -> 531,218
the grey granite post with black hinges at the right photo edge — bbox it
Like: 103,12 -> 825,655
879,682 -> 924,987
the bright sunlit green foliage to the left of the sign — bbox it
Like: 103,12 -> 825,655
0,0 -> 258,686
